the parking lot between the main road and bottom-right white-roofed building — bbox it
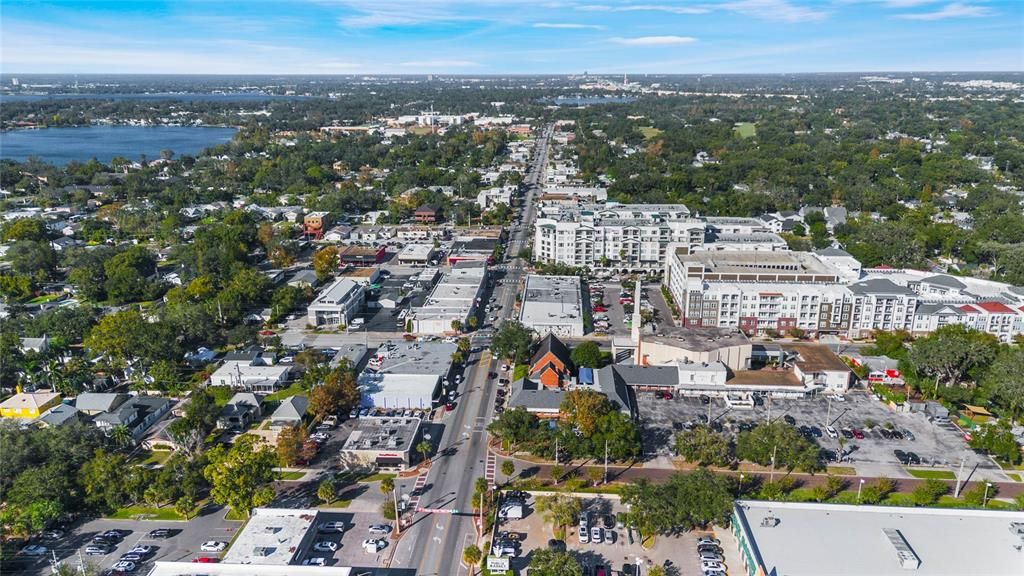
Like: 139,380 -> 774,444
498,497 -> 716,576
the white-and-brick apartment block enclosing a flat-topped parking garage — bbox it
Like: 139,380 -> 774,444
665,247 -> 854,334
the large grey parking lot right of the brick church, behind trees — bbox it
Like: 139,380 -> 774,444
637,393 -> 995,476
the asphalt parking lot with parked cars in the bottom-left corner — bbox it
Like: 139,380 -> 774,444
12,509 -> 242,575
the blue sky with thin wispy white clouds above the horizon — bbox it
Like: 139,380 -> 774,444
0,0 -> 1024,75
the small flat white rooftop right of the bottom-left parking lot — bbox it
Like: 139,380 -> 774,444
222,508 -> 317,566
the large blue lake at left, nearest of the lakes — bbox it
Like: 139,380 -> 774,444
0,126 -> 238,166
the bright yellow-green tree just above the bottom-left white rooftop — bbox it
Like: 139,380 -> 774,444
203,435 -> 278,516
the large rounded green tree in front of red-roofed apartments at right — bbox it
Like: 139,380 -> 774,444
907,324 -> 998,387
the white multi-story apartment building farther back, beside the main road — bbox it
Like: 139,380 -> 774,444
534,204 -> 707,273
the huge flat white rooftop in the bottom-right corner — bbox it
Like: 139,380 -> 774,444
730,500 -> 1024,576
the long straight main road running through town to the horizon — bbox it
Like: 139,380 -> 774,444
392,126 -> 552,576
